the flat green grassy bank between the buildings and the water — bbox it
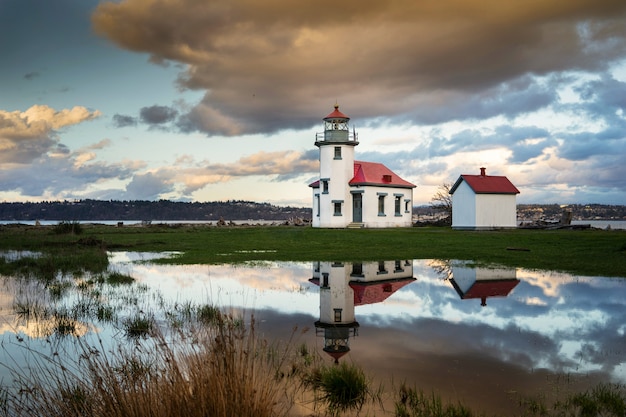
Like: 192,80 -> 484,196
0,225 -> 626,277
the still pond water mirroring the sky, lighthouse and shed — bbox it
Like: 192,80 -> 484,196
0,252 -> 626,415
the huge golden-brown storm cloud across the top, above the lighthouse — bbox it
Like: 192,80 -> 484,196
93,0 -> 626,135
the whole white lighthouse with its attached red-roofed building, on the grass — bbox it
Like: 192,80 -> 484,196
309,105 -> 415,228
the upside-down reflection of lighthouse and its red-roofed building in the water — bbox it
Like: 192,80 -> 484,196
311,261 -> 415,363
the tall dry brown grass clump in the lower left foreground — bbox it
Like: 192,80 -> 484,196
2,317 -> 298,417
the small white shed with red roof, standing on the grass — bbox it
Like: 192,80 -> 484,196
450,168 -> 519,229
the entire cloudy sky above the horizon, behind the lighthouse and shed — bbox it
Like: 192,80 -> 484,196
0,0 -> 626,206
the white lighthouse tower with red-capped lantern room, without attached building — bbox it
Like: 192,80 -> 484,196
312,104 -> 359,227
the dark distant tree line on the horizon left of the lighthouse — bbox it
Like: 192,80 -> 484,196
0,200 -> 311,221
